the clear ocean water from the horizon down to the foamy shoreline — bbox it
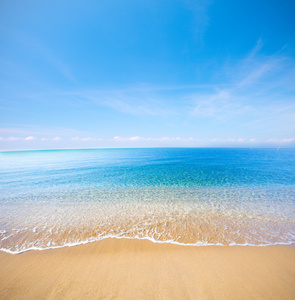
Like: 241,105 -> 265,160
0,148 -> 295,253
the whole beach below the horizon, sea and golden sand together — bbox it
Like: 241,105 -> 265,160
0,148 -> 295,300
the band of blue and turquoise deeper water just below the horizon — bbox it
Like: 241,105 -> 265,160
0,148 -> 295,191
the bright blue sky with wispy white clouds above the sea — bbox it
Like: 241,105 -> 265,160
0,0 -> 295,151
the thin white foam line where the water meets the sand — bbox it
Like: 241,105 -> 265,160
0,235 -> 295,255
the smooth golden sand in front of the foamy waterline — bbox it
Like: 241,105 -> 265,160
0,239 -> 295,299
